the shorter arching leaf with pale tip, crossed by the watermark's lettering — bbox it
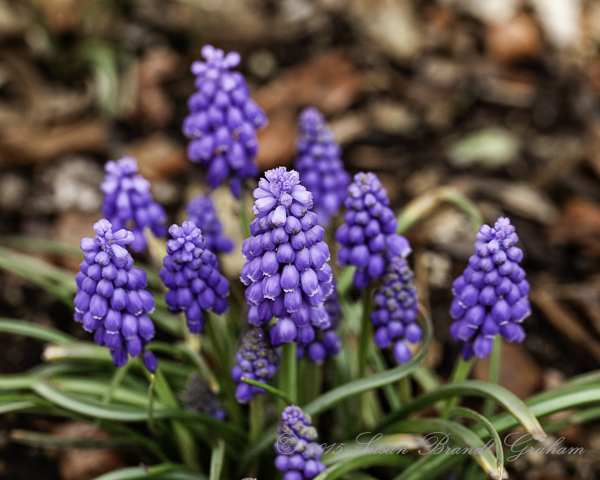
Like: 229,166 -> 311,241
393,418 -> 502,479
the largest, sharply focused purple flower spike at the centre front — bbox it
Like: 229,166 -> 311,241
241,167 -> 333,346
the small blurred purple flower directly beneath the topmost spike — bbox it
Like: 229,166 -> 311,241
185,195 -> 233,253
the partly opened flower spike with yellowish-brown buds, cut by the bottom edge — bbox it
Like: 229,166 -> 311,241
275,405 -> 326,480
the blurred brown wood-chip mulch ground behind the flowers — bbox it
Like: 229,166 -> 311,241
0,0 -> 600,480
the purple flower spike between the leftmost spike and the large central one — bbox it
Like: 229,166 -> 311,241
159,221 -> 229,333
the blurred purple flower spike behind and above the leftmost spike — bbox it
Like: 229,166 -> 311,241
100,157 -> 167,252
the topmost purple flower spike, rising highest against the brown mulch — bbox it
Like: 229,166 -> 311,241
183,45 -> 267,198
